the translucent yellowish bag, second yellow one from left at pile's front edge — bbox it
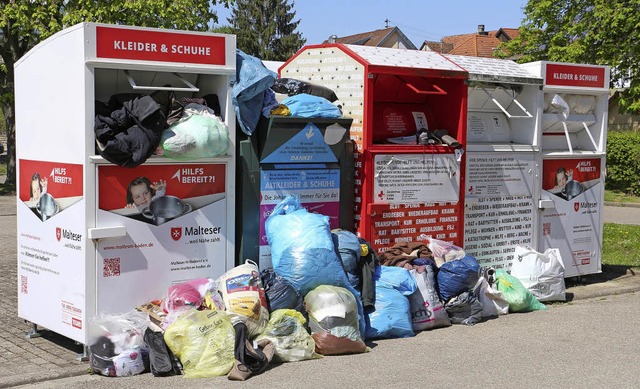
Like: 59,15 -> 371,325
256,309 -> 322,362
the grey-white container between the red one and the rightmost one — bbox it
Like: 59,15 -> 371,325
446,55 -> 542,269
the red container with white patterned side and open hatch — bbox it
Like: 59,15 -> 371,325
280,44 -> 467,251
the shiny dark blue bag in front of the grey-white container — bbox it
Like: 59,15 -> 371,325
436,254 -> 480,304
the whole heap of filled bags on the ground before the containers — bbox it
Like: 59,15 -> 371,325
89,196 -> 564,380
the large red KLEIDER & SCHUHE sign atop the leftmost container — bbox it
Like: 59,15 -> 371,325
96,27 -> 226,65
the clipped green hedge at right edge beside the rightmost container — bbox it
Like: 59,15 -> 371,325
606,131 -> 640,196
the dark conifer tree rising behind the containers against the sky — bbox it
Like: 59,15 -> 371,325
227,0 -> 307,61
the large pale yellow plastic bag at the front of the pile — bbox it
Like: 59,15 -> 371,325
164,309 -> 235,378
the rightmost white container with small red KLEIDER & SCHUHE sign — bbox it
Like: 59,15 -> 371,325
521,61 -> 609,277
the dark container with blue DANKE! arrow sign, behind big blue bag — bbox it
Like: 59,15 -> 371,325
236,115 -> 353,269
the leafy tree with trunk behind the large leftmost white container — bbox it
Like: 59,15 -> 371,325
0,0 -> 233,185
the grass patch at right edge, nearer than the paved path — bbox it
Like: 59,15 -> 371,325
602,223 -> 640,268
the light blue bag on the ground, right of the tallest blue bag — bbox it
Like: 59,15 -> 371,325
365,266 -> 418,339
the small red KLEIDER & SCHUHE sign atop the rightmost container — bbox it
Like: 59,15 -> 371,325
546,63 -> 608,88
